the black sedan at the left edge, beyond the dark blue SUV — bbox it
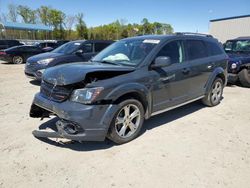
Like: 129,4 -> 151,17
0,45 -> 51,64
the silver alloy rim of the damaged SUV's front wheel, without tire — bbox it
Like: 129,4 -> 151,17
115,104 -> 141,138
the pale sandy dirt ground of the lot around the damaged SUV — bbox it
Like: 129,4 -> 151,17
0,63 -> 250,188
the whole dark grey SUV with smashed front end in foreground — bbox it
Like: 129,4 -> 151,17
30,33 -> 228,144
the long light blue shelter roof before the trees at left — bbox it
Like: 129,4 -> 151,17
0,22 -> 52,31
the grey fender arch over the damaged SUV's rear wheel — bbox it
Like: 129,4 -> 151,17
205,67 -> 227,94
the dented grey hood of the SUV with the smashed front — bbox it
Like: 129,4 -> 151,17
43,62 -> 135,85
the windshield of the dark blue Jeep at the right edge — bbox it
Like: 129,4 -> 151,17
225,40 -> 250,52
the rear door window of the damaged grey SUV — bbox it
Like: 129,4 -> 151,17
186,40 -> 208,60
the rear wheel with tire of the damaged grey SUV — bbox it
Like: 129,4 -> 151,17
202,78 -> 224,107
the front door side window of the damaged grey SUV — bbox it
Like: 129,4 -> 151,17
156,41 -> 184,63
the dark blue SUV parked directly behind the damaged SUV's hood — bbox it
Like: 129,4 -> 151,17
25,40 -> 113,80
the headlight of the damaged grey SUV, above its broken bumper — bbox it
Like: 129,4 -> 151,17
70,87 -> 104,104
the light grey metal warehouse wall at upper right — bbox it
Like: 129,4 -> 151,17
209,17 -> 250,43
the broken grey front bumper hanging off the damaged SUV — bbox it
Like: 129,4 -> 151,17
30,93 -> 117,141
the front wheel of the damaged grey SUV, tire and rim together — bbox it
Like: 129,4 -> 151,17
108,99 -> 144,144
